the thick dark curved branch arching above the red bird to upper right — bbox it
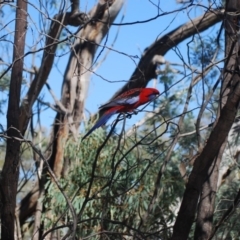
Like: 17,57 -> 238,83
103,10 -> 224,114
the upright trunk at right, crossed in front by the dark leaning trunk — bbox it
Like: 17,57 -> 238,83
194,0 -> 240,240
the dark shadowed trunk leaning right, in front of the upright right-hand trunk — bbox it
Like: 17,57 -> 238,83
172,74 -> 240,239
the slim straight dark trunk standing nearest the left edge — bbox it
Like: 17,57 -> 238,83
0,0 -> 27,240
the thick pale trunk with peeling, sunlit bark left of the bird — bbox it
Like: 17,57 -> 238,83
50,0 -> 123,177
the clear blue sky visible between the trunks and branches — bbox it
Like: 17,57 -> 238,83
0,0 -> 221,132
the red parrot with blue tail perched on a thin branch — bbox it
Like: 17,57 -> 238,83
82,88 -> 159,140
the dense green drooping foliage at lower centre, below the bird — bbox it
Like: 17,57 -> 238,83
43,124 -> 184,239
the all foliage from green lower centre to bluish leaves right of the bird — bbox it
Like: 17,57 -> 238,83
43,30 -> 229,239
